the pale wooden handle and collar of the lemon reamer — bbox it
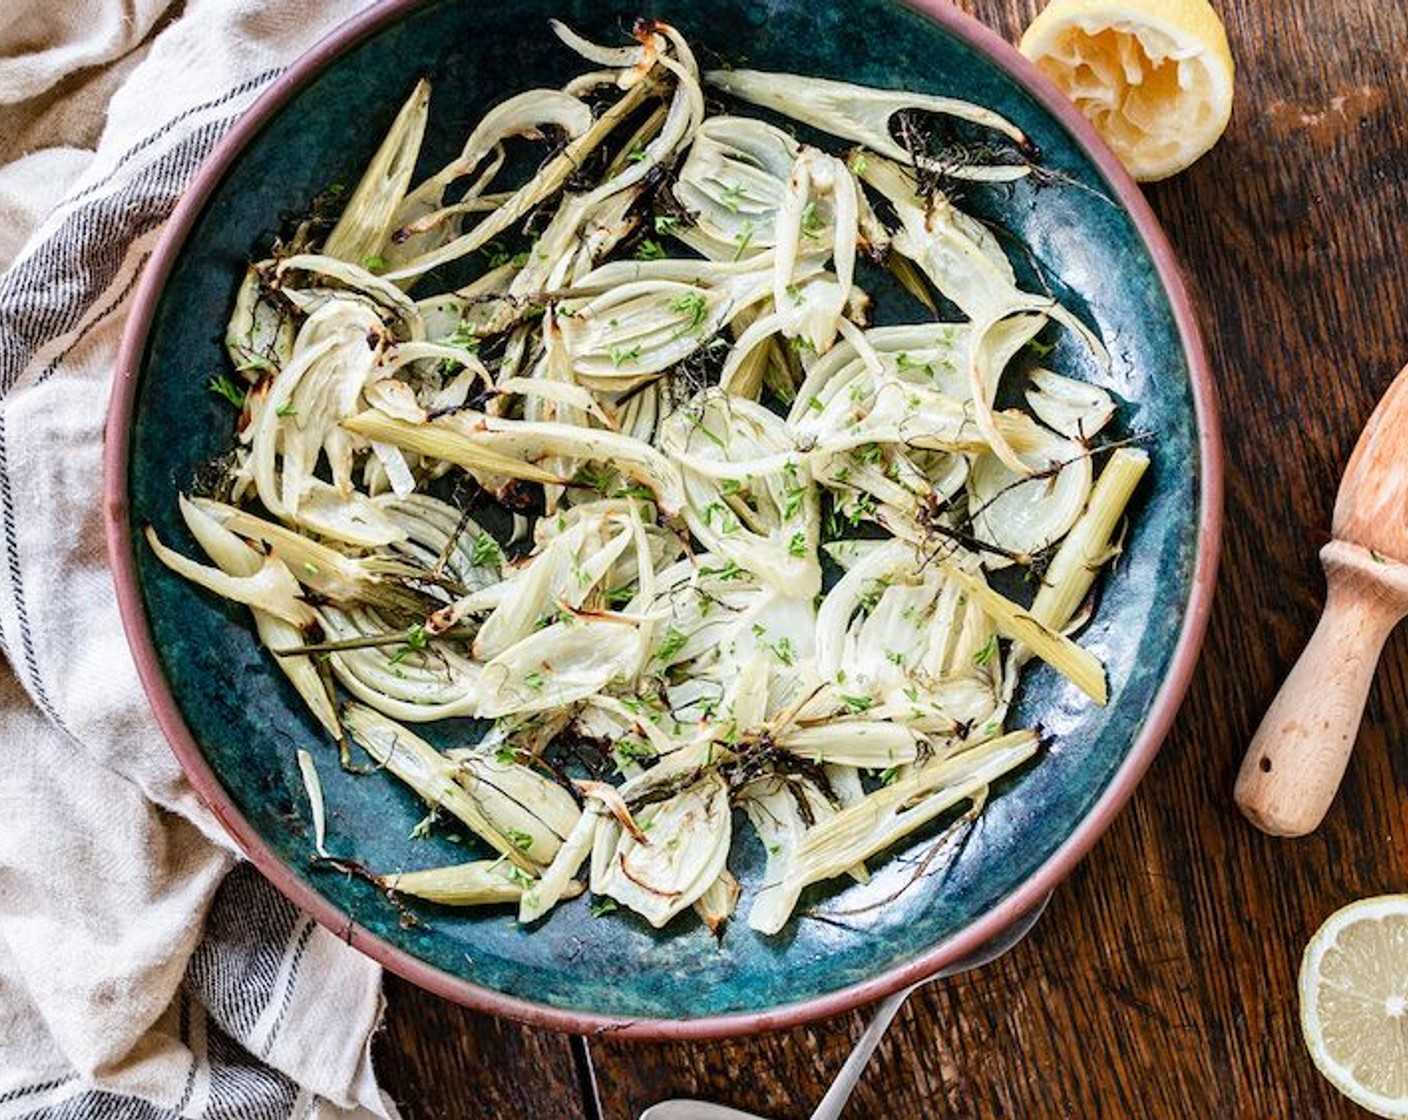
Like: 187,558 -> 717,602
1235,541 -> 1408,837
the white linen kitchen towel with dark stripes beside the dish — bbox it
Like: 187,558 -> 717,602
0,0 -> 396,1120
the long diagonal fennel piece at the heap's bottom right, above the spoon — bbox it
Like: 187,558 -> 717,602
748,731 -> 1039,934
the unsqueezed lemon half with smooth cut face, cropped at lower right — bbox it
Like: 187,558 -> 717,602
1300,895 -> 1408,1117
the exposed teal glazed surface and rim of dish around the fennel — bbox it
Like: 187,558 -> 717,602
107,0 -> 1221,1037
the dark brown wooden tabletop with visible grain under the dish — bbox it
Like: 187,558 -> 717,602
377,0 -> 1408,1120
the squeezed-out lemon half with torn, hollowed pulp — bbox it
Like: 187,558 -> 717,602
1021,0 -> 1235,180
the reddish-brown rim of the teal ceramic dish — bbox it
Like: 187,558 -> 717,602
103,0 -> 1224,1040
